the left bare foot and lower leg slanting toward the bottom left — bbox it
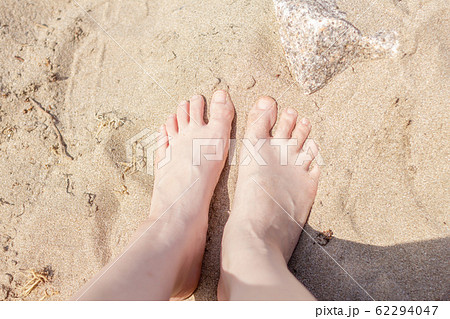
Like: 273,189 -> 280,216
74,91 -> 234,300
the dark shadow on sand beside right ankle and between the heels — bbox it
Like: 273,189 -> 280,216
195,220 -> 450,300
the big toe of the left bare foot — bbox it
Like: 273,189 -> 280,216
209,90 -> 234,129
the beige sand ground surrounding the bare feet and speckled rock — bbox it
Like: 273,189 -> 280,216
0,0 -> 450,300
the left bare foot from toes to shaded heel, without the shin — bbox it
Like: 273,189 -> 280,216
150,91 -> 234,299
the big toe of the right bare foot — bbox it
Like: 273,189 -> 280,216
245,96 -> 277,138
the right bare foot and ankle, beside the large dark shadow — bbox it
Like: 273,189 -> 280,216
218,97 -> 319,300
